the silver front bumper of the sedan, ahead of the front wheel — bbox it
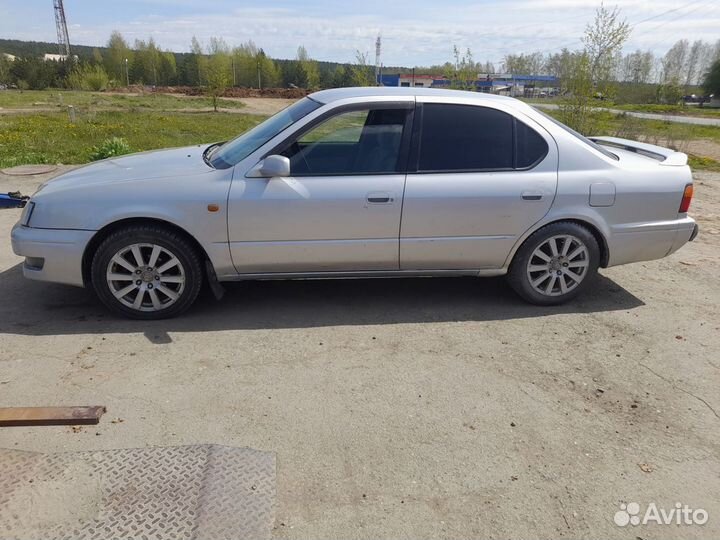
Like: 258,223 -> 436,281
11,223 -> 95,287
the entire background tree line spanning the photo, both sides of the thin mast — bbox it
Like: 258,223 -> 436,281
0,25 -> 720,116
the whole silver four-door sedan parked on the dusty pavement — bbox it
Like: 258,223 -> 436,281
12,88 -> 698,319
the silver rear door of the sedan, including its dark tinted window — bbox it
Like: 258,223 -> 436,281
400,97 -> 558,270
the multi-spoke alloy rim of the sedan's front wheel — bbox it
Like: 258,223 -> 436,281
105,243 -> 185,311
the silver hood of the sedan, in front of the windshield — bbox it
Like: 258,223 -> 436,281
42,145 -> 215,192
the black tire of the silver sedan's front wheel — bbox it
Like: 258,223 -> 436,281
91,225 -> 203,320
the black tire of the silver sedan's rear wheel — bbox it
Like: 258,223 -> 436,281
507,221 -> 600,306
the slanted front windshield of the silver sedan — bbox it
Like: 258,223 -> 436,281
208,98 -> 322,169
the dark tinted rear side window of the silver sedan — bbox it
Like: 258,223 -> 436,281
418,103 -> 548,172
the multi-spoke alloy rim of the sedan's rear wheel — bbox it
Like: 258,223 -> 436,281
527,234 -> 590,296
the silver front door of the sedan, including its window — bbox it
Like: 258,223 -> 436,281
228,103 -> 414,274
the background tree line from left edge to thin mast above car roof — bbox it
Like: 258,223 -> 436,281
0,32 -> 375,90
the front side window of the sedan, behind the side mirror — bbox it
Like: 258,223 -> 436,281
281,109 -> 410,176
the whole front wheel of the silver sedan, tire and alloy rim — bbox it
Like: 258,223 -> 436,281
91,225 -> 202,320
